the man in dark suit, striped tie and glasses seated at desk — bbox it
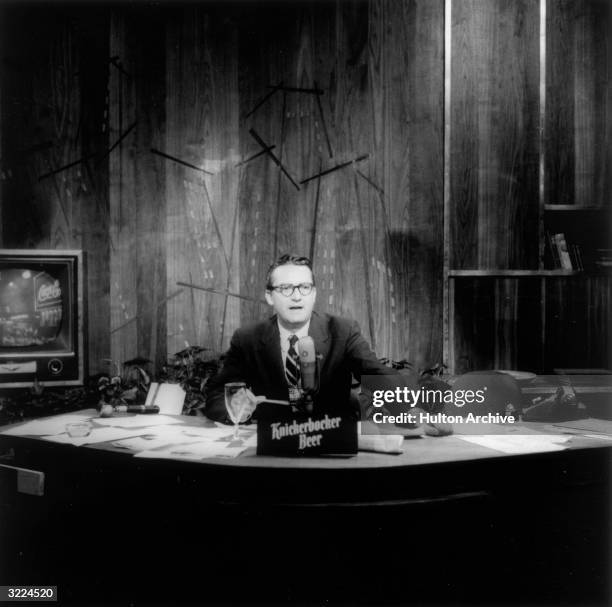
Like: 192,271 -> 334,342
206,255 -> 440,422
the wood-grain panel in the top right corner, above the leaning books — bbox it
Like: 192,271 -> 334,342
545,0 -> 612,206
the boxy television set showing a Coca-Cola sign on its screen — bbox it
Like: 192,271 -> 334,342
0,249 -> 86,389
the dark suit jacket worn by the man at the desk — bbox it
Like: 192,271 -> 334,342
205,312 -> 397,422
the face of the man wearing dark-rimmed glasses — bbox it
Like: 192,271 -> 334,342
266,264 -> 317,328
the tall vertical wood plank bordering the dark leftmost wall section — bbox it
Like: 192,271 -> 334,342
108,9 -> 167,367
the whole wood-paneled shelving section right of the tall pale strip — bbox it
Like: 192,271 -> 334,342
444,0 -> 612,374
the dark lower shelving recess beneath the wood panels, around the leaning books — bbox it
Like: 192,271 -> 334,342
445,205 -> 612,373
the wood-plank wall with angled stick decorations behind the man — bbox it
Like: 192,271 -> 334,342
2,0 -> 444,371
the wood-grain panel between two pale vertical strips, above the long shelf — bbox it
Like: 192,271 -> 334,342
450,0 -> 539,268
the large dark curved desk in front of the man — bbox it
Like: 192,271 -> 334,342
0,418 -> 612,605
